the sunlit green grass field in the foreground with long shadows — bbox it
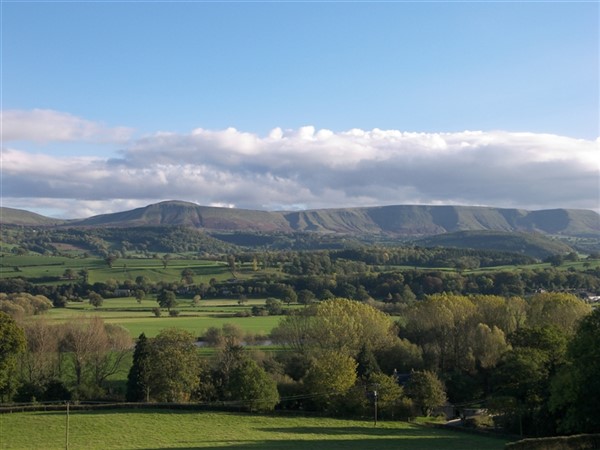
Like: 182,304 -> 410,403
0,410 -> 507,450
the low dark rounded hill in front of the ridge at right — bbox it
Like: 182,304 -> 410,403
415,231 -> 573,259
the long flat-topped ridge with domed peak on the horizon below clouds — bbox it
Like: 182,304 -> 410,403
2,201 -> 600,238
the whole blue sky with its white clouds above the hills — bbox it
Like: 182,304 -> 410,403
0,0 -> 600,218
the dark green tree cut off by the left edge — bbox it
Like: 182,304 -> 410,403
0,311 -> 25,401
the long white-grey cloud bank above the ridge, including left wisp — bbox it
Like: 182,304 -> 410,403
2,110 -> 600,217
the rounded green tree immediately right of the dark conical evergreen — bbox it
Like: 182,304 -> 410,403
149,328 -> 200,402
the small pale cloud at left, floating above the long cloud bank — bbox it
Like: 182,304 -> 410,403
2,109 -> 132,142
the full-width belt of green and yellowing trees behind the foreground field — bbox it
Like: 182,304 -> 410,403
0,293 -> 600,435
